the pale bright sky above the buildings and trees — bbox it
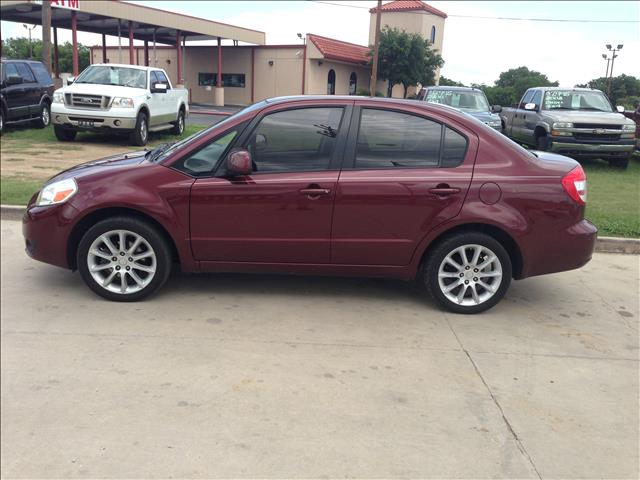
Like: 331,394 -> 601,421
2,0 -> 640,86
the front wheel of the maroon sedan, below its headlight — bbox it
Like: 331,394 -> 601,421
76,217 -> 171,302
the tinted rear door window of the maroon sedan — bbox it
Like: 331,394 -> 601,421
355,109 -> 442,168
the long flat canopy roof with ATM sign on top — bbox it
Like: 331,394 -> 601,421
0,0 -> 265,45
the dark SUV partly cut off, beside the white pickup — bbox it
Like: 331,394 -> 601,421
0,58 -> 54,136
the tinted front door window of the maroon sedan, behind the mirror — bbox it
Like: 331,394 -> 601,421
247,107 -> 343,173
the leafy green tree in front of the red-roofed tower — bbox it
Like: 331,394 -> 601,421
369,26 -> 444,97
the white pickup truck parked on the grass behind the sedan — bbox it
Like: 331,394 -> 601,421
51,63 -> 189,146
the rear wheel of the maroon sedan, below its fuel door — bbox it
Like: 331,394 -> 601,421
422,232 -> 511,313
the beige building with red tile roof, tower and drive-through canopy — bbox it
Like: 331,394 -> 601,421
0,0 -> 447,105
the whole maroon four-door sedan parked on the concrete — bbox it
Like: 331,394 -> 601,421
23,96 -> 597,313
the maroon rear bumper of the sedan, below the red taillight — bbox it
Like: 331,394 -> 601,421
520,219 -> 598,278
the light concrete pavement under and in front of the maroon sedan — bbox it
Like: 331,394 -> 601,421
1,221 -> 640,478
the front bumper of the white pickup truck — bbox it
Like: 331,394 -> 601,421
51,103 -> 136,132
